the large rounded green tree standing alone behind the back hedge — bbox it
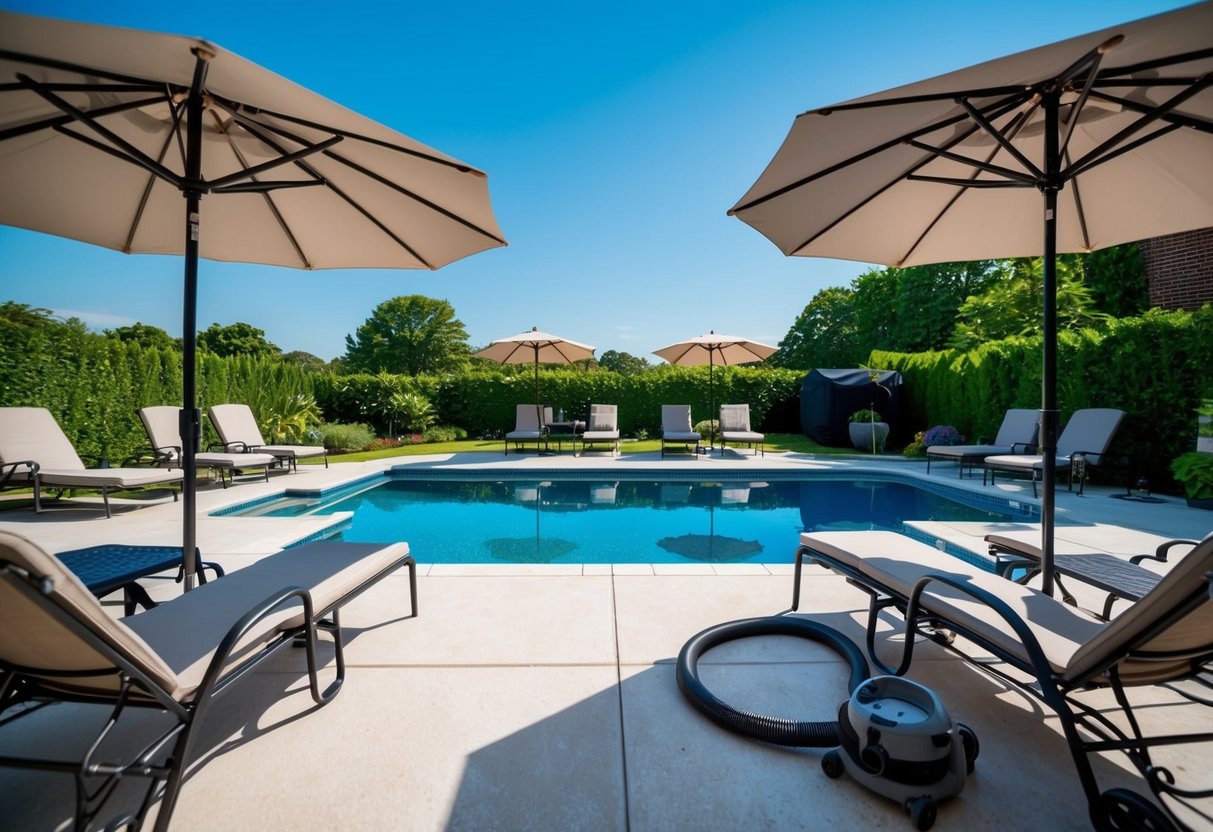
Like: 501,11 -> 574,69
344,295 -> 472,376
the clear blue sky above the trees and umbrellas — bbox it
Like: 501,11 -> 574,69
0,0 -> 1185,361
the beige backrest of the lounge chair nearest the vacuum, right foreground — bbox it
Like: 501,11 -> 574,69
1066,534 -> 1213,684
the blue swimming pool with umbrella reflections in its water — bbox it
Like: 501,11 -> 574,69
222,474 -> 1029,564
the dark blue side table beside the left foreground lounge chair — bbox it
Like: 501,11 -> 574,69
55,543 -> 223,615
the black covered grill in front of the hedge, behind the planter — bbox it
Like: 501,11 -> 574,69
801,370 -> 906,448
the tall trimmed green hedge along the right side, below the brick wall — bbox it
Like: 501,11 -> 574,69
869,306 -> 1213,490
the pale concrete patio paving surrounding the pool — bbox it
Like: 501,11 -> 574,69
0,454 -> 1213,831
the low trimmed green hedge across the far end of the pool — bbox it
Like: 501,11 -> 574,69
315,366 -> 803,437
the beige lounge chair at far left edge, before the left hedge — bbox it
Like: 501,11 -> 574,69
0,408 -> 182,517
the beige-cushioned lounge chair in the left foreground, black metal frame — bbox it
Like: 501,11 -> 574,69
0,532 -> 417,830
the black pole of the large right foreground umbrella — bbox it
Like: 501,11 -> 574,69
1041,90 -> 1061,595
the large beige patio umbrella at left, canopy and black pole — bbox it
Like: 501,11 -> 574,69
0,11 -> 505,588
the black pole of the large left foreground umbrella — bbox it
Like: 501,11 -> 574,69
180,50 -> 210,592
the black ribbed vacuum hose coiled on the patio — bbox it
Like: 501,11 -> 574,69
677,616 -> 870,748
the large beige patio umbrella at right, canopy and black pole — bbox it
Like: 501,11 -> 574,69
730,4 -> 1213,591
